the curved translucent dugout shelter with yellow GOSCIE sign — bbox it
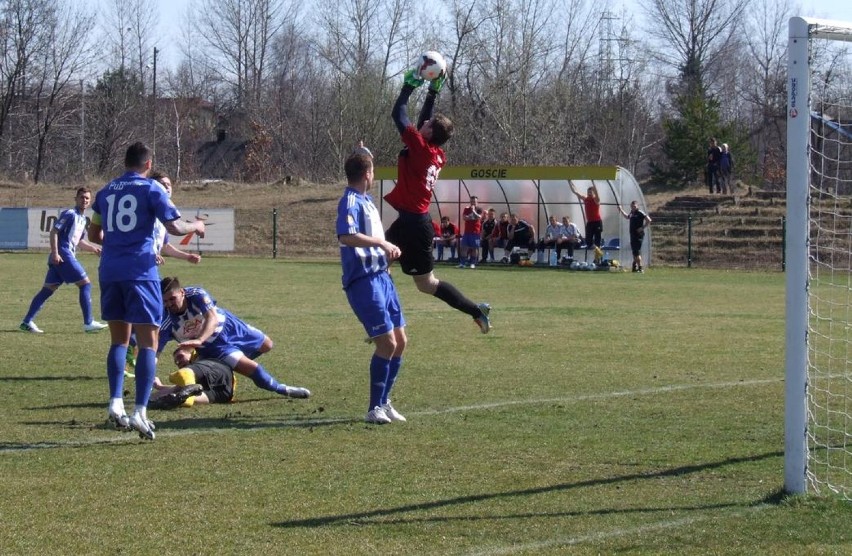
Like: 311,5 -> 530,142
373,166 -> 653,268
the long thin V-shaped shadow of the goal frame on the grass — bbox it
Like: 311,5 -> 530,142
271,451 -> 784,528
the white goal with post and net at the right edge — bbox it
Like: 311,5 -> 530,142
784,17 -> 852,500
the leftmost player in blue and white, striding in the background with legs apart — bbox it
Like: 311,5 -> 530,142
20,187 -> 107,334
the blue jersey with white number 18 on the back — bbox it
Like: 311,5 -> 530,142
92,172 -> 180,282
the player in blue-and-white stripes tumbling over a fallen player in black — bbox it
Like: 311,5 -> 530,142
157,276 -> 311,398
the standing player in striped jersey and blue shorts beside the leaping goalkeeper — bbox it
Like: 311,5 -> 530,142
336,144 -> 408,425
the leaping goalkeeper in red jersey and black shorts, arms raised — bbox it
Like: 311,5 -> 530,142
385,69 -> 491,334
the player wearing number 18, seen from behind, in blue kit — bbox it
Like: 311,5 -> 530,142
89,143 -> 204,440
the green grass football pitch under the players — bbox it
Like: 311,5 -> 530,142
0,254 -> 852,555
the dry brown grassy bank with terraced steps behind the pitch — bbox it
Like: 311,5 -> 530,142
0,182 -> 800,270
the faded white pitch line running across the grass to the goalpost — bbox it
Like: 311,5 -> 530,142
0,378 -> 783,455
